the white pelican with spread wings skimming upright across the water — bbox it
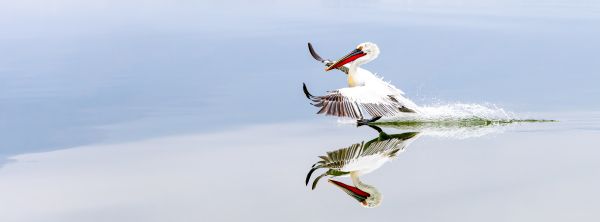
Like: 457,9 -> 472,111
302,42 -> 419,125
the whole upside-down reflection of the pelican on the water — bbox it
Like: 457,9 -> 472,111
306,126 -> 418,207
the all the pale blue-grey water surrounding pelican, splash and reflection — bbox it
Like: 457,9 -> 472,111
0,0 -> 600,221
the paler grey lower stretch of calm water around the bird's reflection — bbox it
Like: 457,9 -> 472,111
0,114 -> 600,221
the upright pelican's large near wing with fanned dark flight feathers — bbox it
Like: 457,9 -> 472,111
303,85 -> 414,119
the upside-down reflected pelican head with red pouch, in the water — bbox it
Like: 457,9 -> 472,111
328,179 -> 382,208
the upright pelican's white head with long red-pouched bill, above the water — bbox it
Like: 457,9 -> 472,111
325,42 -> 379,71
